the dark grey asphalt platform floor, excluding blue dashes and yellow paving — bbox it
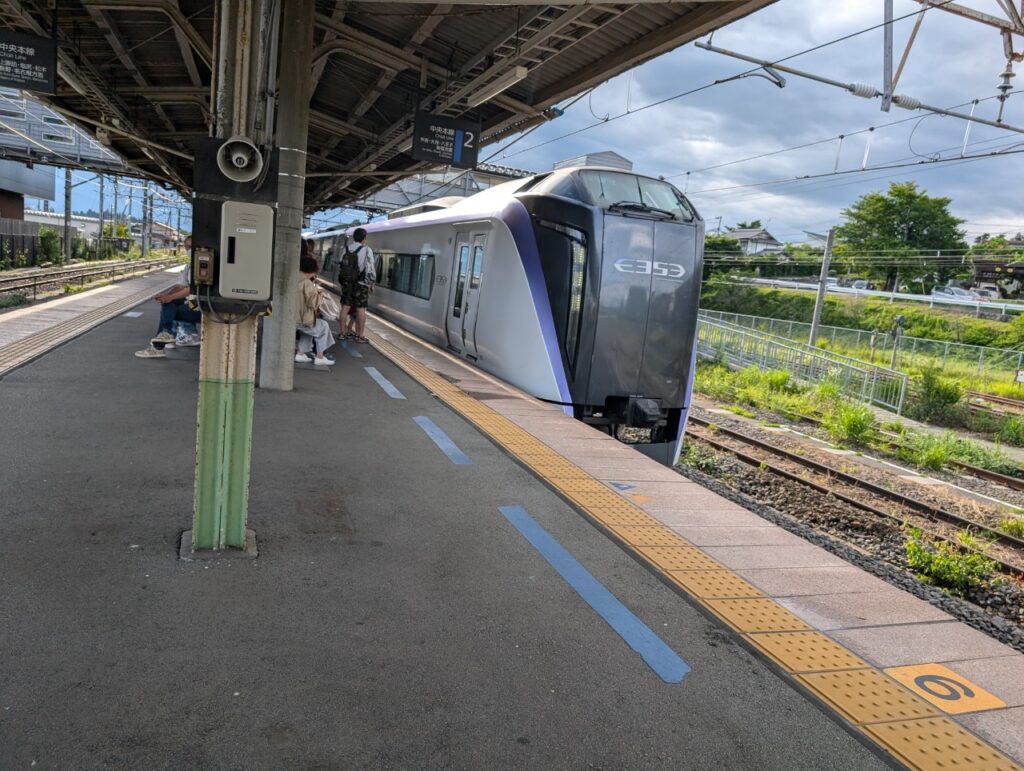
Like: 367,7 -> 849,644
0,306 -> 886,771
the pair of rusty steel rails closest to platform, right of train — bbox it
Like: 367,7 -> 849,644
689,416 -> 1024,561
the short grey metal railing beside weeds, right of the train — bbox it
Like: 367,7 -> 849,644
697,315 -> 907,415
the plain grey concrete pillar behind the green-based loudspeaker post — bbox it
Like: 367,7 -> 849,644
259,0 -> 315,391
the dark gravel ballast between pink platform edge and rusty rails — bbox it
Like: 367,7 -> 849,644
677,453 -> 1024,652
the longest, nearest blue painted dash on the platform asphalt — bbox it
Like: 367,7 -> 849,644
499,506 -> 690,683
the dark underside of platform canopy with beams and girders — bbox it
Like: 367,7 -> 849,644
0,0 -> 774,208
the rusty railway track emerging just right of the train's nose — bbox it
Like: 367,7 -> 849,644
689,416 -> 1024,575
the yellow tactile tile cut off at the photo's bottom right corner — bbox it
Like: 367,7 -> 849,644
862,718 -> 1022,771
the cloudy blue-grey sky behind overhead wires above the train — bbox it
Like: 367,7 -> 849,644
483,0 -> 1024,241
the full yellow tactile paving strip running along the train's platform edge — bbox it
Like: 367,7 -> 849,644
370,333 -> 1024,771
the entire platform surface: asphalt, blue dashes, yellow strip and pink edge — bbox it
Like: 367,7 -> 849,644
0,286 -> 1024,769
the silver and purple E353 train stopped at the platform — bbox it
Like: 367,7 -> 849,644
308,167 -> 705,465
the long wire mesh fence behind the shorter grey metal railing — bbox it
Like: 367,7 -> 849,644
700,309 -> 1024,377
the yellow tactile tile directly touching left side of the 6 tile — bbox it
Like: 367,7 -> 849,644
797,670 -> 938,725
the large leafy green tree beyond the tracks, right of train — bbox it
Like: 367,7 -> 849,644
836,182 -> 967,289
